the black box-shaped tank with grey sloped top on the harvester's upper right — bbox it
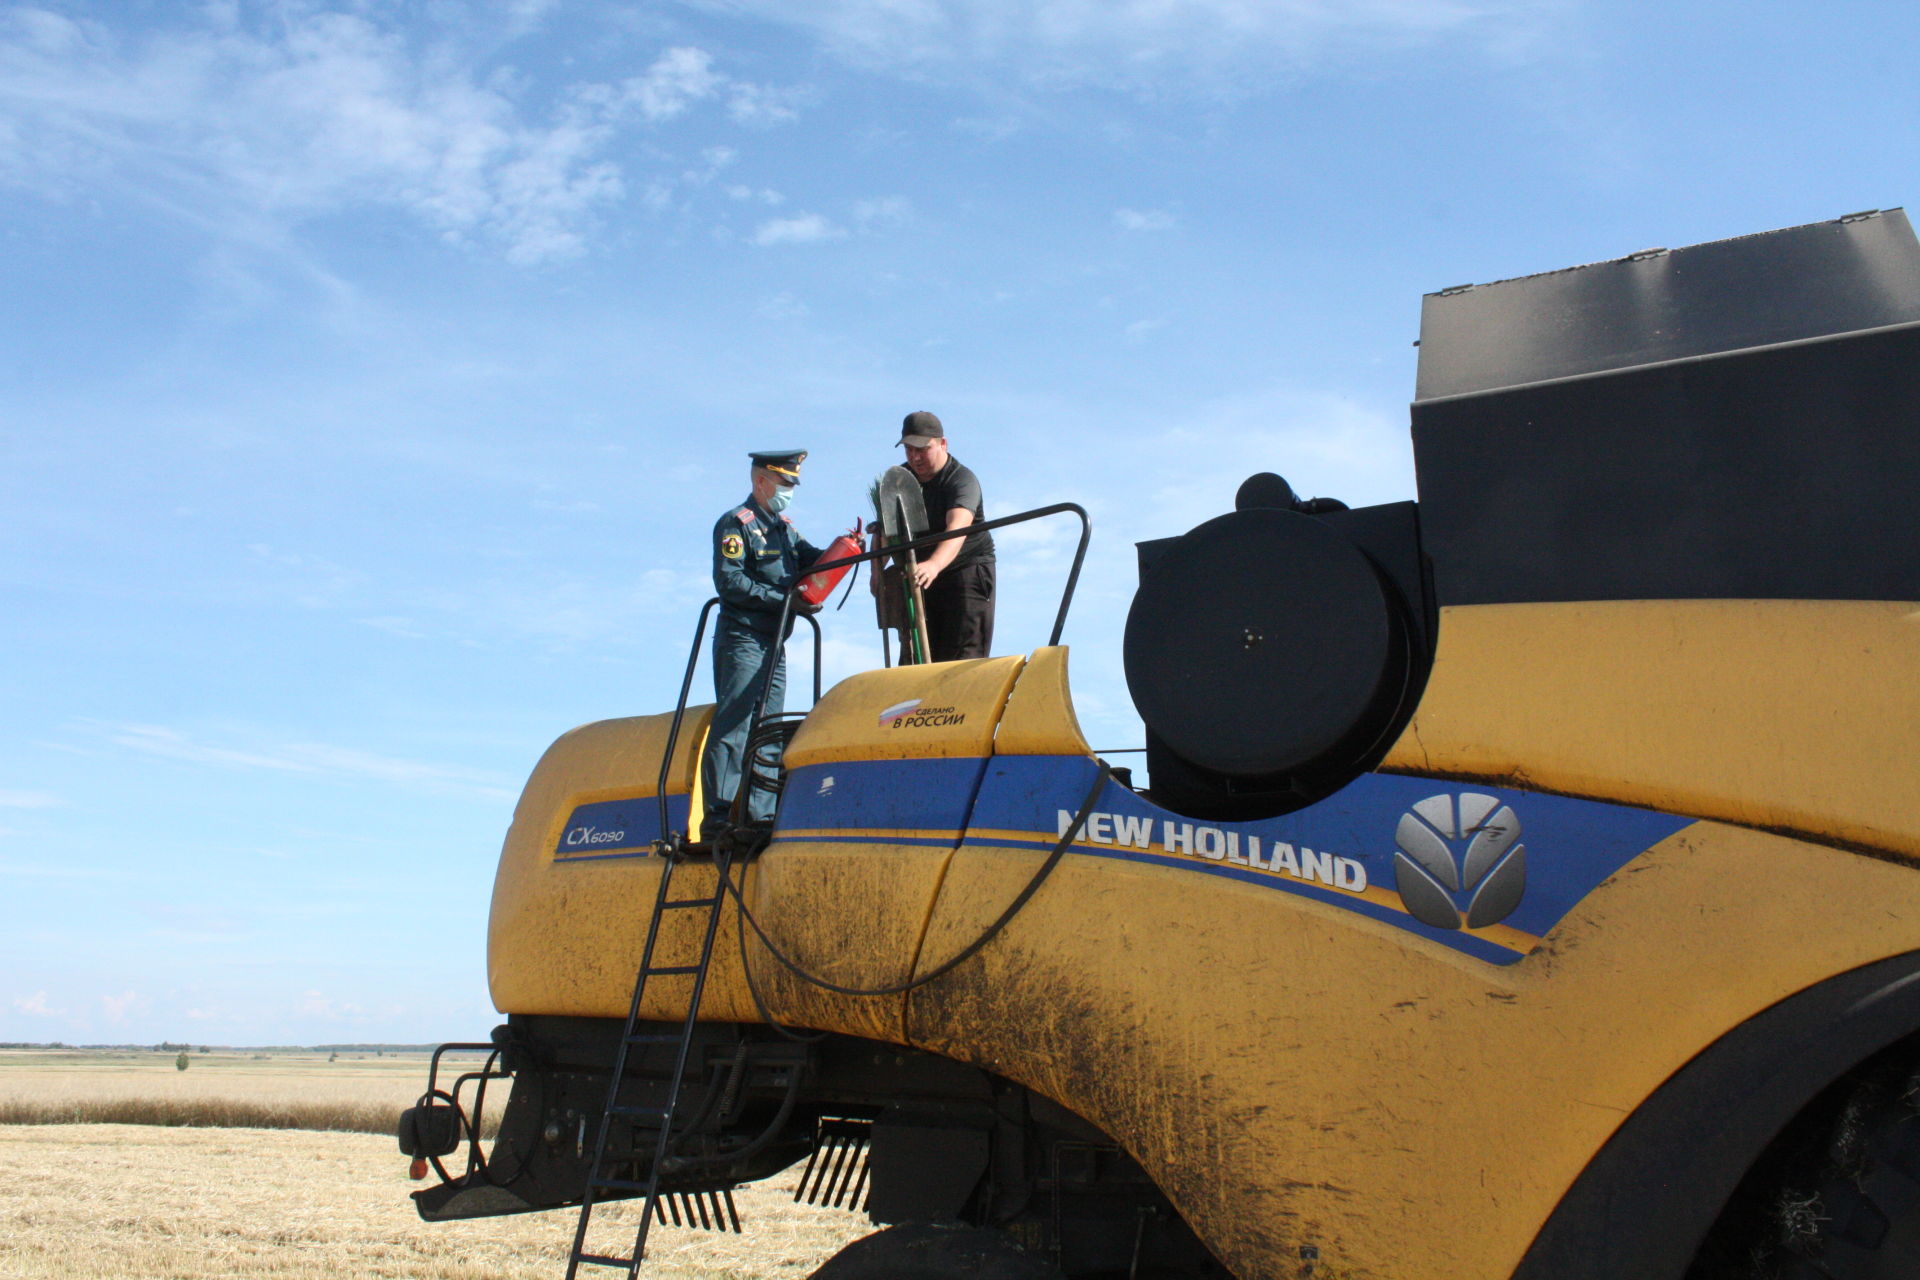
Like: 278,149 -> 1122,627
1413,209 -> 1920,606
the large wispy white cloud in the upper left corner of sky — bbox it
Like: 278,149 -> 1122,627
0,6 -> 795,265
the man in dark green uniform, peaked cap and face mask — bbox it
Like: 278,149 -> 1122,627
701,449 -> 820,839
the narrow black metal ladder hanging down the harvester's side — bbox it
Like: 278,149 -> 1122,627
566,841 -> 737,1280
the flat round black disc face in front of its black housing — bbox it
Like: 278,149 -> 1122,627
1123,509 -> 1405,777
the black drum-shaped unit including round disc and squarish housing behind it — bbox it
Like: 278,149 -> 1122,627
1123,503 -> 1430,821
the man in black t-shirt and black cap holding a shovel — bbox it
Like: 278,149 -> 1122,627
900,409 -> 993,662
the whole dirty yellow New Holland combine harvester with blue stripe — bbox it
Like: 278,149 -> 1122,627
401,211 -> 1920,1280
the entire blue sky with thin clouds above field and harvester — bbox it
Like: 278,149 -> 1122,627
0,0 -> 1920,1044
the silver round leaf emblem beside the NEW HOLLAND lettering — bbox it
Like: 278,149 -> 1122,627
1394,791 -> 1526,929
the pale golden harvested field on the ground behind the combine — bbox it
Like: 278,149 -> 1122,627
0,1054 -> 872,1280
